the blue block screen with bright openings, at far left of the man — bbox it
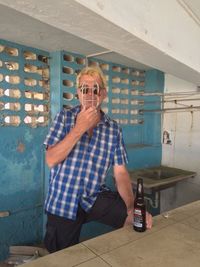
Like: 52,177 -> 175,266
0,40 -> 50,127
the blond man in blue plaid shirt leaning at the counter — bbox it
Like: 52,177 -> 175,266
44,67 -> 152,252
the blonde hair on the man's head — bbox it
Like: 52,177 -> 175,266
76,67 -> 107,89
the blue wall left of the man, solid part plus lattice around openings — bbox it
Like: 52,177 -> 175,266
0,40 -> 49,260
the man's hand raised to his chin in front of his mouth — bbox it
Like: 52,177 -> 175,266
74,107 -> 100,134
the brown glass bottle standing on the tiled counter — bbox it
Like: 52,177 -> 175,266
133,178 -> 146,232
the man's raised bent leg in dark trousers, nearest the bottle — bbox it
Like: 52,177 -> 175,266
87,191 -> 127,228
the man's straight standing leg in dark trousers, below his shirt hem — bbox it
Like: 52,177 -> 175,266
44,207 -> 85,253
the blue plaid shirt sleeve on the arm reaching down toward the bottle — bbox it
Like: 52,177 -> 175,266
112,128 -> 128,166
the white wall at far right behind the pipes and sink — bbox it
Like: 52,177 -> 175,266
161,74 -> 200,212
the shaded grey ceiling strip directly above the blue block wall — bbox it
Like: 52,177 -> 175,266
0,4 -> 150,69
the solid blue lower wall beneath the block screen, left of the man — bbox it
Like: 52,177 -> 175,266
0,127 -> 44,259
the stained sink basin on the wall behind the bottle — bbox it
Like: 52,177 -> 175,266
129,166 -> 196,190
